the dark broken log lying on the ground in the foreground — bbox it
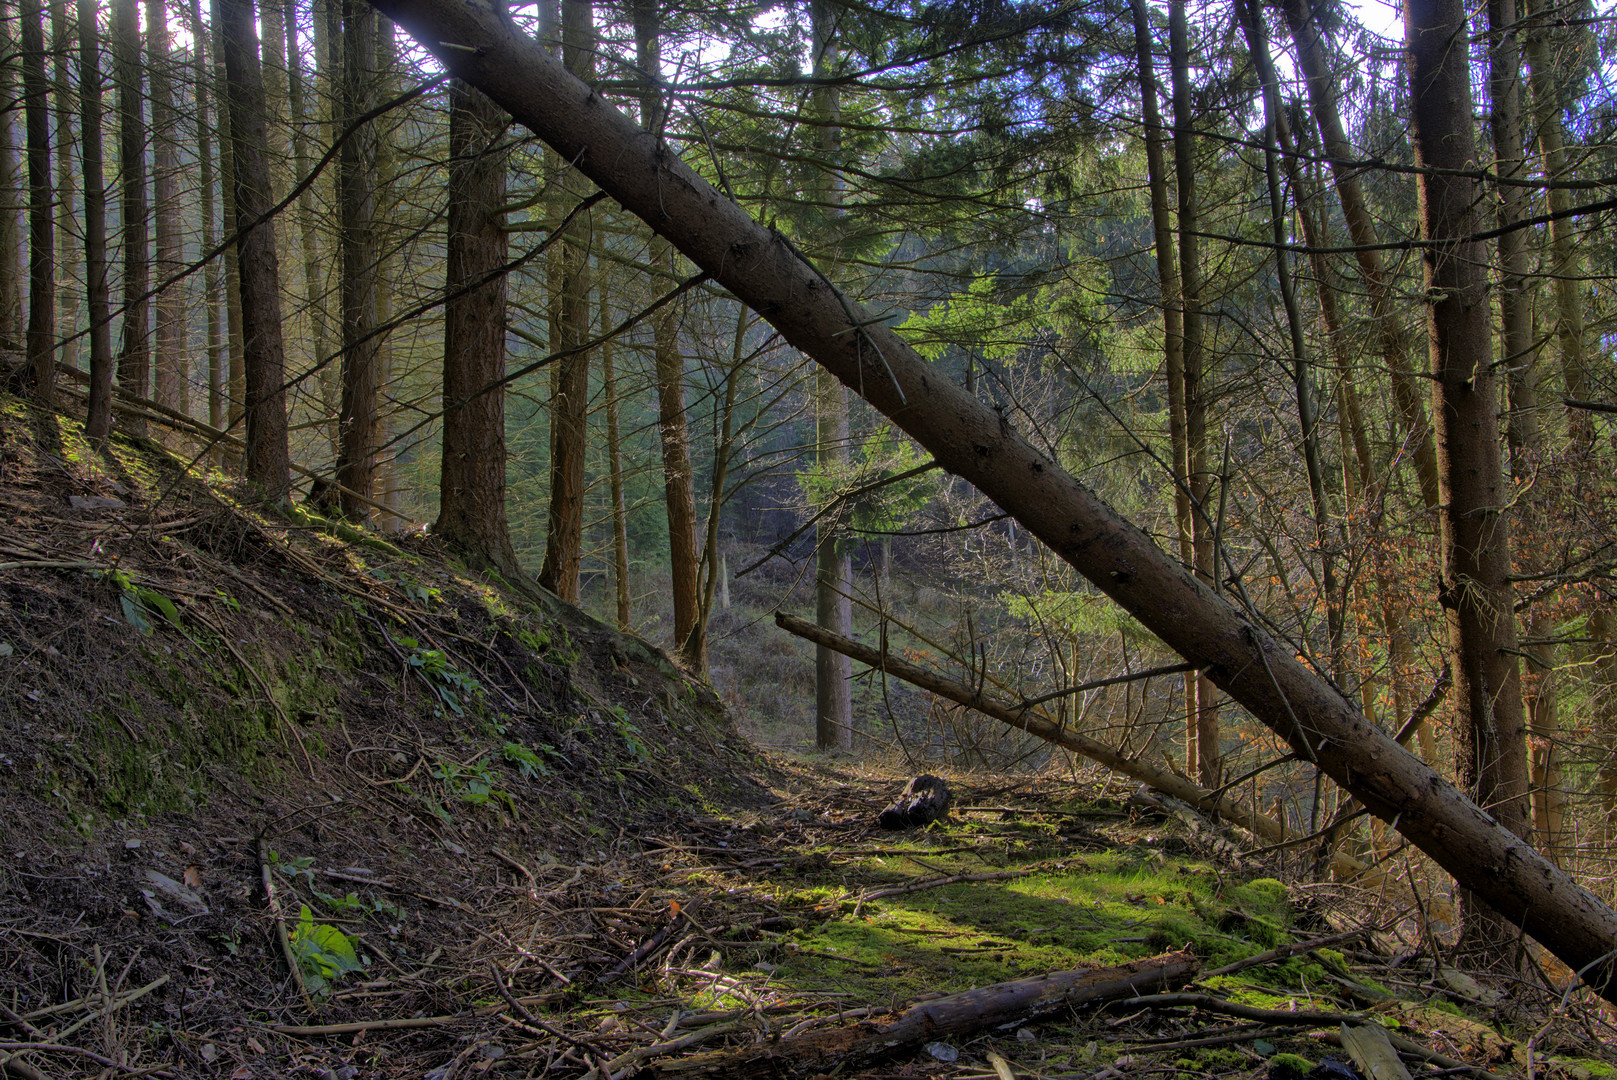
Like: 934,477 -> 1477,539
637,952 -> 1197,1080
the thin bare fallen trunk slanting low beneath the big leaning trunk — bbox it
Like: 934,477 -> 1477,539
775,611 -> 1368,878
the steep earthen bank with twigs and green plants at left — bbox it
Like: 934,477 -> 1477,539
0,399 -> 771,1075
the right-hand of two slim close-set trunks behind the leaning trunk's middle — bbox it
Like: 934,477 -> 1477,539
1169,0 -> 1221,787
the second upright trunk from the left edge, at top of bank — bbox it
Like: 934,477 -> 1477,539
18,0 -> 57,409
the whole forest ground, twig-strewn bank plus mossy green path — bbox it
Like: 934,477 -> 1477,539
0,399 -> 1617,1080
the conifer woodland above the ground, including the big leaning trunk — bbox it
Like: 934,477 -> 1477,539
0,0 -> 1617,1072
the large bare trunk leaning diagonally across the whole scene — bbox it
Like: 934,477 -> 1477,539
360,0 -> 1617,1001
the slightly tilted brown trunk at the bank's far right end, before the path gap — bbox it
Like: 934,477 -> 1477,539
634,0 -> 707,674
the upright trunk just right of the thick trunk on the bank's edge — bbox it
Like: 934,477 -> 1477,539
538,0 -> 595,603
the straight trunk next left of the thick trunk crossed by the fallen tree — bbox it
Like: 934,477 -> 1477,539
330,0 -> 380,521
